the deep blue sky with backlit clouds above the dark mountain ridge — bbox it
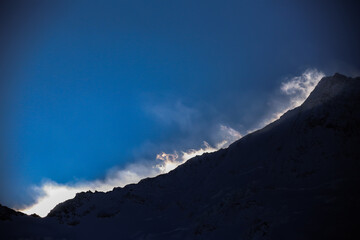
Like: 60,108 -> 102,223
0,0 -> 360,215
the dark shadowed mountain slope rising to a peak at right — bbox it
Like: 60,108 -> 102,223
0,74 -> 360,239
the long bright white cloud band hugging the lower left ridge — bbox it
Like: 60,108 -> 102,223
19,125 -> 241,217
